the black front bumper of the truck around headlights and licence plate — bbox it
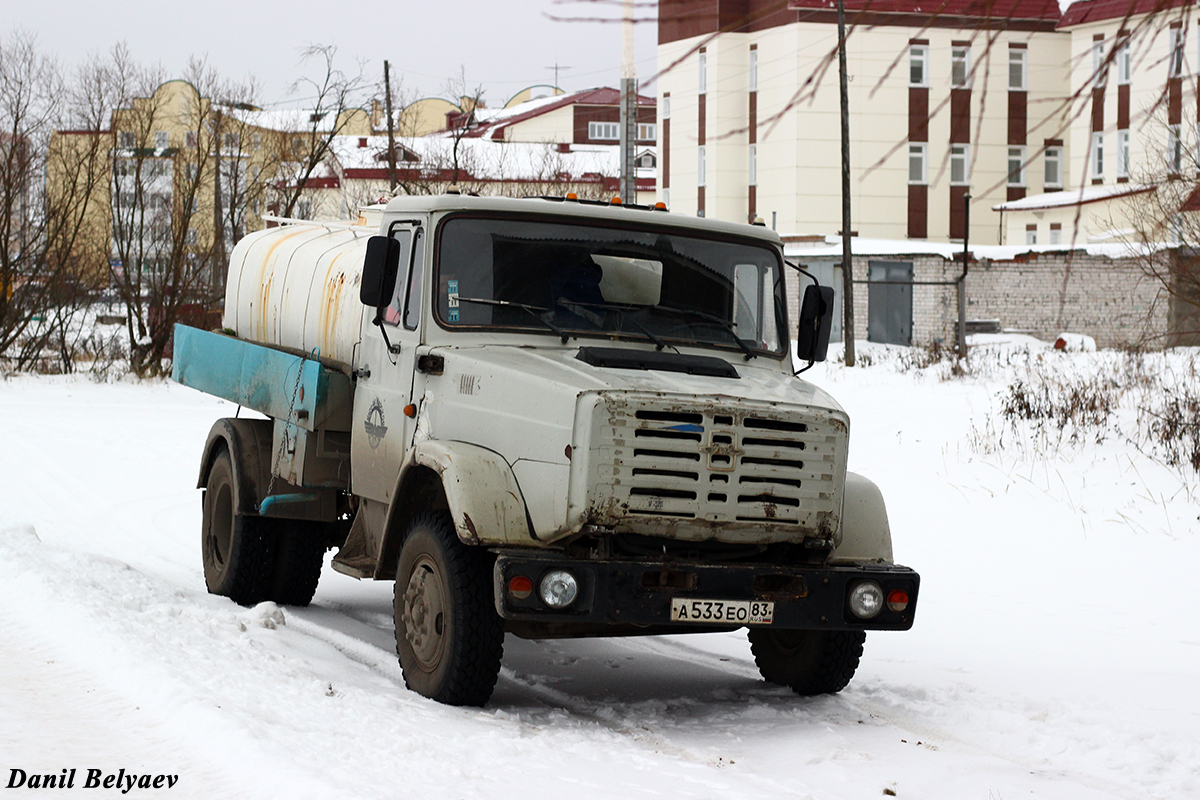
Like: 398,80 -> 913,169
494,552 -> 920,631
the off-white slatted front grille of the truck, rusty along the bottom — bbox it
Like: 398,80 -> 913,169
589,395 -> 847,541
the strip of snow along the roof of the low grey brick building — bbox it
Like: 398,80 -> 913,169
784,235 -> 1171,261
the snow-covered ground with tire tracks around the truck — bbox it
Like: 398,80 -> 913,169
0,344 -> 1200,800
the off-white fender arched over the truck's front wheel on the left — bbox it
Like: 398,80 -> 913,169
392,439 -> 534,545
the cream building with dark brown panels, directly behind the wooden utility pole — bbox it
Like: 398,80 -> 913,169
658,0 -> 1067,243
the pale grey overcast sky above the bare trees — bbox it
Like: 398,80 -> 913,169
7,0 -> 656,107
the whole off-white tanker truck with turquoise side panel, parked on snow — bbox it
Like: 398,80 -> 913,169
173,194 -> 919,705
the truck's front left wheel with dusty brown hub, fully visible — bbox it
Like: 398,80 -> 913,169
392,511 -> 504,705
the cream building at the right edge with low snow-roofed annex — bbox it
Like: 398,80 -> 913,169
996,0 -> 1200,243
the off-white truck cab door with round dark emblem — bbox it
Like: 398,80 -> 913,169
350,219 -> 426,503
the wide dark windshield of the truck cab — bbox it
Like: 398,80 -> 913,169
434,217 -> 785,355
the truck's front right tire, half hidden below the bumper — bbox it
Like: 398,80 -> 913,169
749,628 -> 866,696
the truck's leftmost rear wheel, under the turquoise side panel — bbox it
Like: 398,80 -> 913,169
200,450 -> 275,606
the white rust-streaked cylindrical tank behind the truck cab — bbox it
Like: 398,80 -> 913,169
224,223 -> 377,365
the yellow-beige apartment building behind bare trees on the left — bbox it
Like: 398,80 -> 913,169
47,80 -> 372,282
